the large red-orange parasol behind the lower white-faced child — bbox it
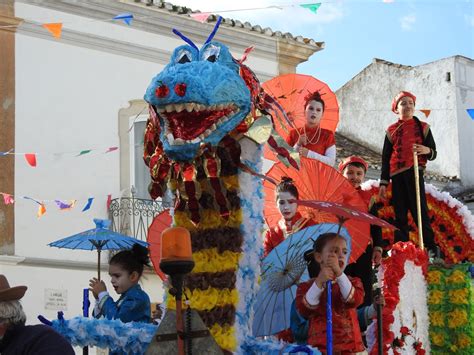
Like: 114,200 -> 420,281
263,158 -> 370,262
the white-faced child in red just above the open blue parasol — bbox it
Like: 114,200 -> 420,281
263,176 -> 316,256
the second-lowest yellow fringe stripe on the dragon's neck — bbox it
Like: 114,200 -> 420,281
167,287 -> 239,311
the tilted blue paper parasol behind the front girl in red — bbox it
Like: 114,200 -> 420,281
253,223 -> 351,336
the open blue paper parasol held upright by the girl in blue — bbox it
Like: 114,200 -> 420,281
48,218 -> 148,280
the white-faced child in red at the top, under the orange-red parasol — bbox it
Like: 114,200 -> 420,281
286,92 -> 336,166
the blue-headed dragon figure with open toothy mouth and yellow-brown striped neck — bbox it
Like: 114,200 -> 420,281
144,21 -> 297,352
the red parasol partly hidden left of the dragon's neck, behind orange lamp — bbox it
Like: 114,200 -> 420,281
146,210 -> 173,281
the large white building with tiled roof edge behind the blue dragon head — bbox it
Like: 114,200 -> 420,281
0,0 -> 324,352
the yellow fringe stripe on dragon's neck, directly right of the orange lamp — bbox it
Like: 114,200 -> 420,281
193,248 -> 242,273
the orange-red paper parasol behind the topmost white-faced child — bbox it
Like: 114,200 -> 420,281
262,74 -> 339,160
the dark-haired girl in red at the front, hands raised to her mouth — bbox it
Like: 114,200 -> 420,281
296,233 -> 365,354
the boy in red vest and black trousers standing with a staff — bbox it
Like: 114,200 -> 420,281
380,91 -> 437,253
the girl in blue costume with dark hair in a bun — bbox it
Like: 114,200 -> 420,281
89,244 -> 151,323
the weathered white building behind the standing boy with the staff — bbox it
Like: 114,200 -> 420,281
336,56 -> 474,207
